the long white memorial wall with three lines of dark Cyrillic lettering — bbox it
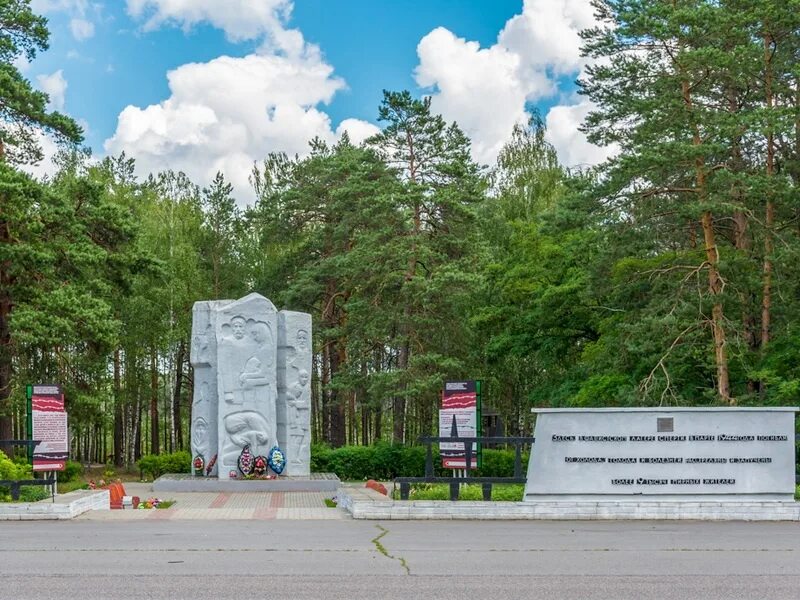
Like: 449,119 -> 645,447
524,407 -> 798,502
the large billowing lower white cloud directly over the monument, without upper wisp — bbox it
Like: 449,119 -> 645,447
105,54 -> 377,200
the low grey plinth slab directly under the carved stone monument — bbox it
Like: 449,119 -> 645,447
153,473 -> 340,493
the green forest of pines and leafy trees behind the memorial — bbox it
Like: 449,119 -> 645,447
0,0 -> 800,465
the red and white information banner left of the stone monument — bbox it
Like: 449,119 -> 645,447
31,385 -> 69,471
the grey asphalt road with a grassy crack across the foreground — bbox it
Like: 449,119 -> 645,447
0,521 -> 800,600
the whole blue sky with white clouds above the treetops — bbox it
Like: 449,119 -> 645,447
24,0 -> 603,200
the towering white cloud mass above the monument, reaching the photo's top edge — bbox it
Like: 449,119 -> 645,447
105,0 -> 378,201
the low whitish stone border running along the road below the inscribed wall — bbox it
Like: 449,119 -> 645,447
339,489 -> 800,521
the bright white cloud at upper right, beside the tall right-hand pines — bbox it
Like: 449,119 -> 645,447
415,0 -> 609,166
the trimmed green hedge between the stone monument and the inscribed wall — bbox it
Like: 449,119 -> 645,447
311,443 -> 528,481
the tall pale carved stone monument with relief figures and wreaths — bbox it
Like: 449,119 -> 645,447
191,294 -> 311,479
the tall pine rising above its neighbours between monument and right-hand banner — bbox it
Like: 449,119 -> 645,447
369,91 -> 485,442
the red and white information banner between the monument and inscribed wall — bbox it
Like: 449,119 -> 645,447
439,381 -> 480,469
